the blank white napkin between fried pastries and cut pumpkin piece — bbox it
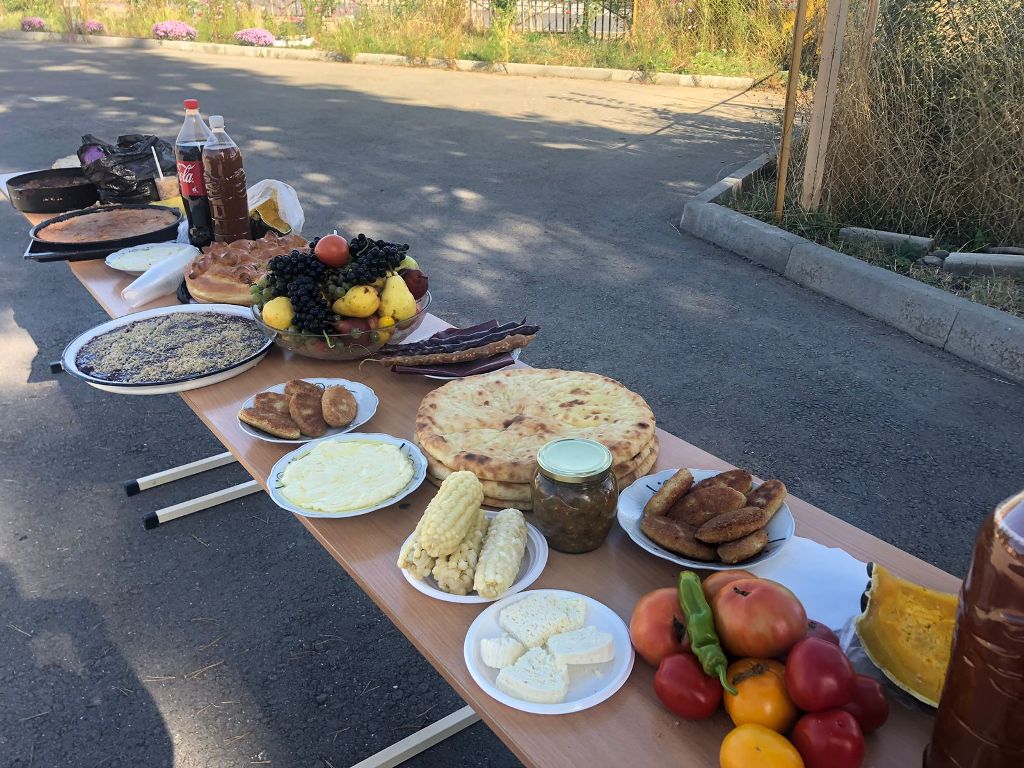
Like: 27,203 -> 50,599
746,536 -> 868,632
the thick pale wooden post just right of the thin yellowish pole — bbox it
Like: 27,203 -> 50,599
800,0 -> 850,210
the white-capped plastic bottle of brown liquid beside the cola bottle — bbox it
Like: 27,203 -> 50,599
203,115 -> 252,243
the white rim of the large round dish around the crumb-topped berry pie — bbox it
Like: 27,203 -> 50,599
60,304 -> 273,394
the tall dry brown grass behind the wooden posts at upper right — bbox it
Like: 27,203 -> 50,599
791,0 -> 1024,244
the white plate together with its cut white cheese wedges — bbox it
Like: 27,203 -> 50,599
463,590 -> 634,715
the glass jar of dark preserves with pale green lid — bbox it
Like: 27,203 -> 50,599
530,437 -> 618,554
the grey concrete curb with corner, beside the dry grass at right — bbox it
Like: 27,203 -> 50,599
680,165 -> 1024,384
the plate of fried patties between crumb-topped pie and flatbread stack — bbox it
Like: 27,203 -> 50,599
239,379 -> 378,444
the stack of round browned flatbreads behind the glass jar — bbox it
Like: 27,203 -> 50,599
416,368 -> 658,509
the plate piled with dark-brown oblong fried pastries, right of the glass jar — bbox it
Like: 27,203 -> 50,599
618,469 -> 796,570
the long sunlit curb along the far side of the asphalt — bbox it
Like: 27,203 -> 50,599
0,30 -> 754,90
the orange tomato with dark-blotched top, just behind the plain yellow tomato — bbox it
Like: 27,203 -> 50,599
724,658 -> 800,733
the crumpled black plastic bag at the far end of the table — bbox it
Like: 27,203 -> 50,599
78,133 -> 177,203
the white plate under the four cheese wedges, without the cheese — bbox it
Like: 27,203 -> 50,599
463,590 -> 634,715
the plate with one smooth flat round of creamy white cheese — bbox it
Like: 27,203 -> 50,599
267,433 -> 427,517
